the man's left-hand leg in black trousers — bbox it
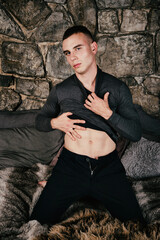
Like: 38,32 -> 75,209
31,151 -> 90,224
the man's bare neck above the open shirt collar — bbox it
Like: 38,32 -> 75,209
76,65 -> 97,91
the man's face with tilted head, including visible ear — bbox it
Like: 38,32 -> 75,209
63,33 -> 97,74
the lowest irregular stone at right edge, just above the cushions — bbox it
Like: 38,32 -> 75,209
130,86 -> 160,116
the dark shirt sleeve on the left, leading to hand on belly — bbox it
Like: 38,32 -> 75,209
35,87 -> 60,132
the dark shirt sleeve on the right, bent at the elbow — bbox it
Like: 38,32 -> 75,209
107,83 -> 142,142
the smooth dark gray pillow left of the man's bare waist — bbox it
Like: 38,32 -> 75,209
0,127 -> 63,167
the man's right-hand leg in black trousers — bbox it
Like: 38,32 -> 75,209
92,153 -> 144,221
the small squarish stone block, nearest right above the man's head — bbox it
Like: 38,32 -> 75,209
98,10 -> 119,33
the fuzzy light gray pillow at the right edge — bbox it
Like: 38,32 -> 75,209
121,138 -> 160,179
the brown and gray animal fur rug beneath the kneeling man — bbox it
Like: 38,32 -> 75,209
0,164 -> 160,240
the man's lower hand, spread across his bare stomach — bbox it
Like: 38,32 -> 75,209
51,112 -> 86,141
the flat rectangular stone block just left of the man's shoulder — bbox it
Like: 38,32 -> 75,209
16,78 -> 49,98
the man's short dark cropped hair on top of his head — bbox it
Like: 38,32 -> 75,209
63,25 -> 94,41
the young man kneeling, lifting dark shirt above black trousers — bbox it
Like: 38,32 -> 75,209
31,26 -> 143,224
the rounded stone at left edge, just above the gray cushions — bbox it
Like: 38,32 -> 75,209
0,88 -> 21,111
